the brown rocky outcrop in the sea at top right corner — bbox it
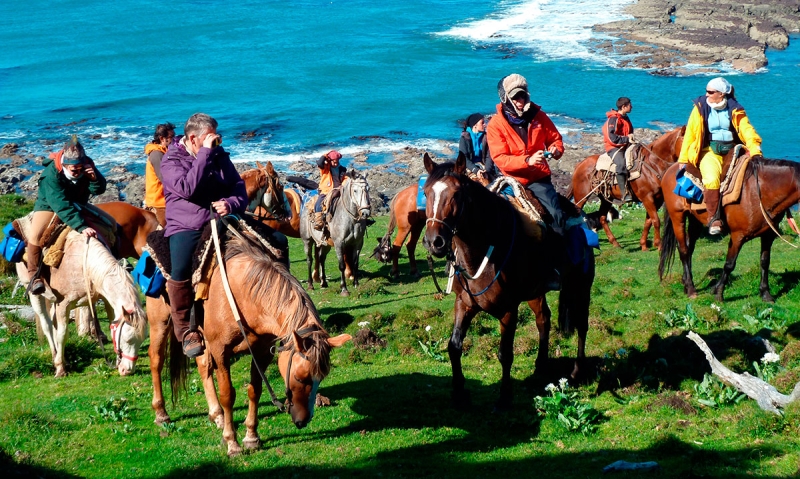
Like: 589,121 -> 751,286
594,0 -> 800,75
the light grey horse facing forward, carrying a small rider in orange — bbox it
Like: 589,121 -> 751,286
300,171 -> 372,296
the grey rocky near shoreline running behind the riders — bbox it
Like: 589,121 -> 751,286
0,128 -> 661,215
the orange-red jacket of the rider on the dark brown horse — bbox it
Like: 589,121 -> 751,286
486,104 -> 564,186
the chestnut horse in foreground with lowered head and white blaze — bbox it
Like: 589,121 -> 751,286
152,233 -> 351,456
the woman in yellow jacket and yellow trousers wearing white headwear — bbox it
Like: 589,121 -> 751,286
678,77 -> 761,235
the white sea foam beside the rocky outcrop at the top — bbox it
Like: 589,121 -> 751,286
437,0 -> 633,63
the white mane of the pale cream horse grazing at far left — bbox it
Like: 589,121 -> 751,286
74,232 -> 147,337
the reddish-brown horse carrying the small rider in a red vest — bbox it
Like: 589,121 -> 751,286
567,126 -> 686,251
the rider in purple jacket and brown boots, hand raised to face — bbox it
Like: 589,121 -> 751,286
161,113 -> 247,358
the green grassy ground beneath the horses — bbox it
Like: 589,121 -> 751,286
0,203 -> 800,478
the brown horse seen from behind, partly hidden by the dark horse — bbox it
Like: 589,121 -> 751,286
372,183 -> 425,278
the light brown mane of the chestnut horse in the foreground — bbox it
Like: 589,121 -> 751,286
225,238 -> 331,379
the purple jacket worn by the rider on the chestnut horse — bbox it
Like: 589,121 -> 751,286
161,136 -> 247,236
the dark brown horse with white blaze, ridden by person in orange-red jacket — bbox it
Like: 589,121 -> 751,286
423,154 -> 594,409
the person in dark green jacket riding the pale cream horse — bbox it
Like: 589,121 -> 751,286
25,135 -> 106,295
